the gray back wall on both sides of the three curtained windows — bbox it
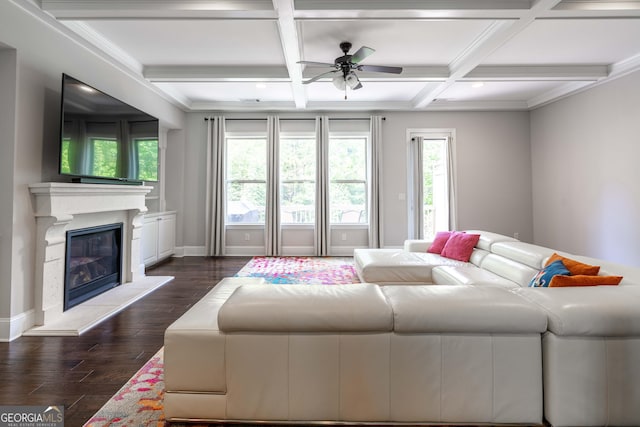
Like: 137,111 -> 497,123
167,112 -> 533,253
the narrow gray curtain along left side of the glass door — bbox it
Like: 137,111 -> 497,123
409,136 -> 424,239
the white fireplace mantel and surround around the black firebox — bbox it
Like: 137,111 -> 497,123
29,182 -> 170,334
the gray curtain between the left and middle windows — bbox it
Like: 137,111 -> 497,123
265,116 -> 282,256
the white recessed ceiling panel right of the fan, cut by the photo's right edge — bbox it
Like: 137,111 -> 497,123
483,19 -> 640,65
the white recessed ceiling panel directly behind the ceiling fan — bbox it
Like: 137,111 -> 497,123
299,20 -> 492,66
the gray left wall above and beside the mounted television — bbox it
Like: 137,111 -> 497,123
0,1 -> 184,339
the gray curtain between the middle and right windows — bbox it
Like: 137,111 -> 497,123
315,116 -> 330,256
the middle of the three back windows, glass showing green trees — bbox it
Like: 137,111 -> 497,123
280,137 -> 316,224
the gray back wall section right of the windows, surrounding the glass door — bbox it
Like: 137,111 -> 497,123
383,112 -> 533,246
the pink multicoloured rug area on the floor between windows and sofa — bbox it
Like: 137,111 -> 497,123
236,257 -> 360,285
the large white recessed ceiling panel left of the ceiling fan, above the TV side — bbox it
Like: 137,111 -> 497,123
80,20 -> 284,65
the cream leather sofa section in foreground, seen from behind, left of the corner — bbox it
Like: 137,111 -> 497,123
164,278 -> 547,425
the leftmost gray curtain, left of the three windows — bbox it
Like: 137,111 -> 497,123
205,116 -> 225,256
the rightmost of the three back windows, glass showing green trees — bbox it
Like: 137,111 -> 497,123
329,136 -> 368,224
